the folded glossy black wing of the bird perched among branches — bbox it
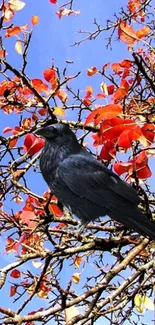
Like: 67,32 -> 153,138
58,154 -> 140,206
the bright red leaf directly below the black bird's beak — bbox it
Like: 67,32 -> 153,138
23,134 -> 44,156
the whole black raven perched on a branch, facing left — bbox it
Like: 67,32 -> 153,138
35,124 -> 155,239
